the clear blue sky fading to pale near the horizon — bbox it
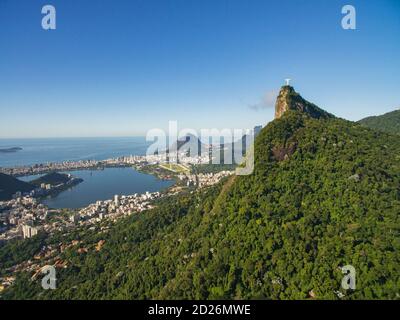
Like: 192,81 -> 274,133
0,0 -> 400,138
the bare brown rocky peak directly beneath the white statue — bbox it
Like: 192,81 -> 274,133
275,86 -> 334,119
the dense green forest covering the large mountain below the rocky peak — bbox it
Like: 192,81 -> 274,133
0,88 -> 400,299
